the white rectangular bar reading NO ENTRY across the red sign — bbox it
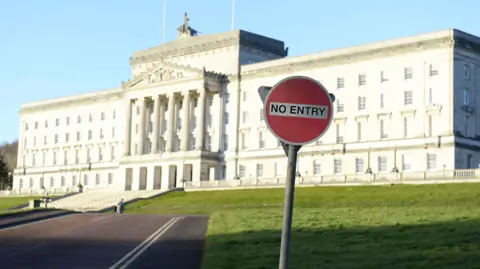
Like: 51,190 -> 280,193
268,102 -> 328,119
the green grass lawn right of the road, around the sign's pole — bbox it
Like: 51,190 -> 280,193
126,184 -> 480,269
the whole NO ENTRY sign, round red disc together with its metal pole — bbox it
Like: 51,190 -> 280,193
258,76 -> 335,269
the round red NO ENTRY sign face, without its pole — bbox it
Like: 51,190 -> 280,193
263,76 -> 333,145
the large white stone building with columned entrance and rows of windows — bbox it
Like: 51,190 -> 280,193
13,15 -> 480,190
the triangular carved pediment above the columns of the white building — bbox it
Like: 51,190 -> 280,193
122,62 -> 204,89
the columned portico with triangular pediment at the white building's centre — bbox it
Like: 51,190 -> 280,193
120,59 -> 224,190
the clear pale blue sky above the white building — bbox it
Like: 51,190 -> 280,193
0,0 -> 480,142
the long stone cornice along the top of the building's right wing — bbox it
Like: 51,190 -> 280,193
236,36 -> 454,79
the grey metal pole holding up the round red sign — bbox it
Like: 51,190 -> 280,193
278,145 -> 300,269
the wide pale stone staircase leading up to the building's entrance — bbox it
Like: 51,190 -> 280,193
48,189 -> 171,212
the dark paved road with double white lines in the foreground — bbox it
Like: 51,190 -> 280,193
0,213 -> 208,269
